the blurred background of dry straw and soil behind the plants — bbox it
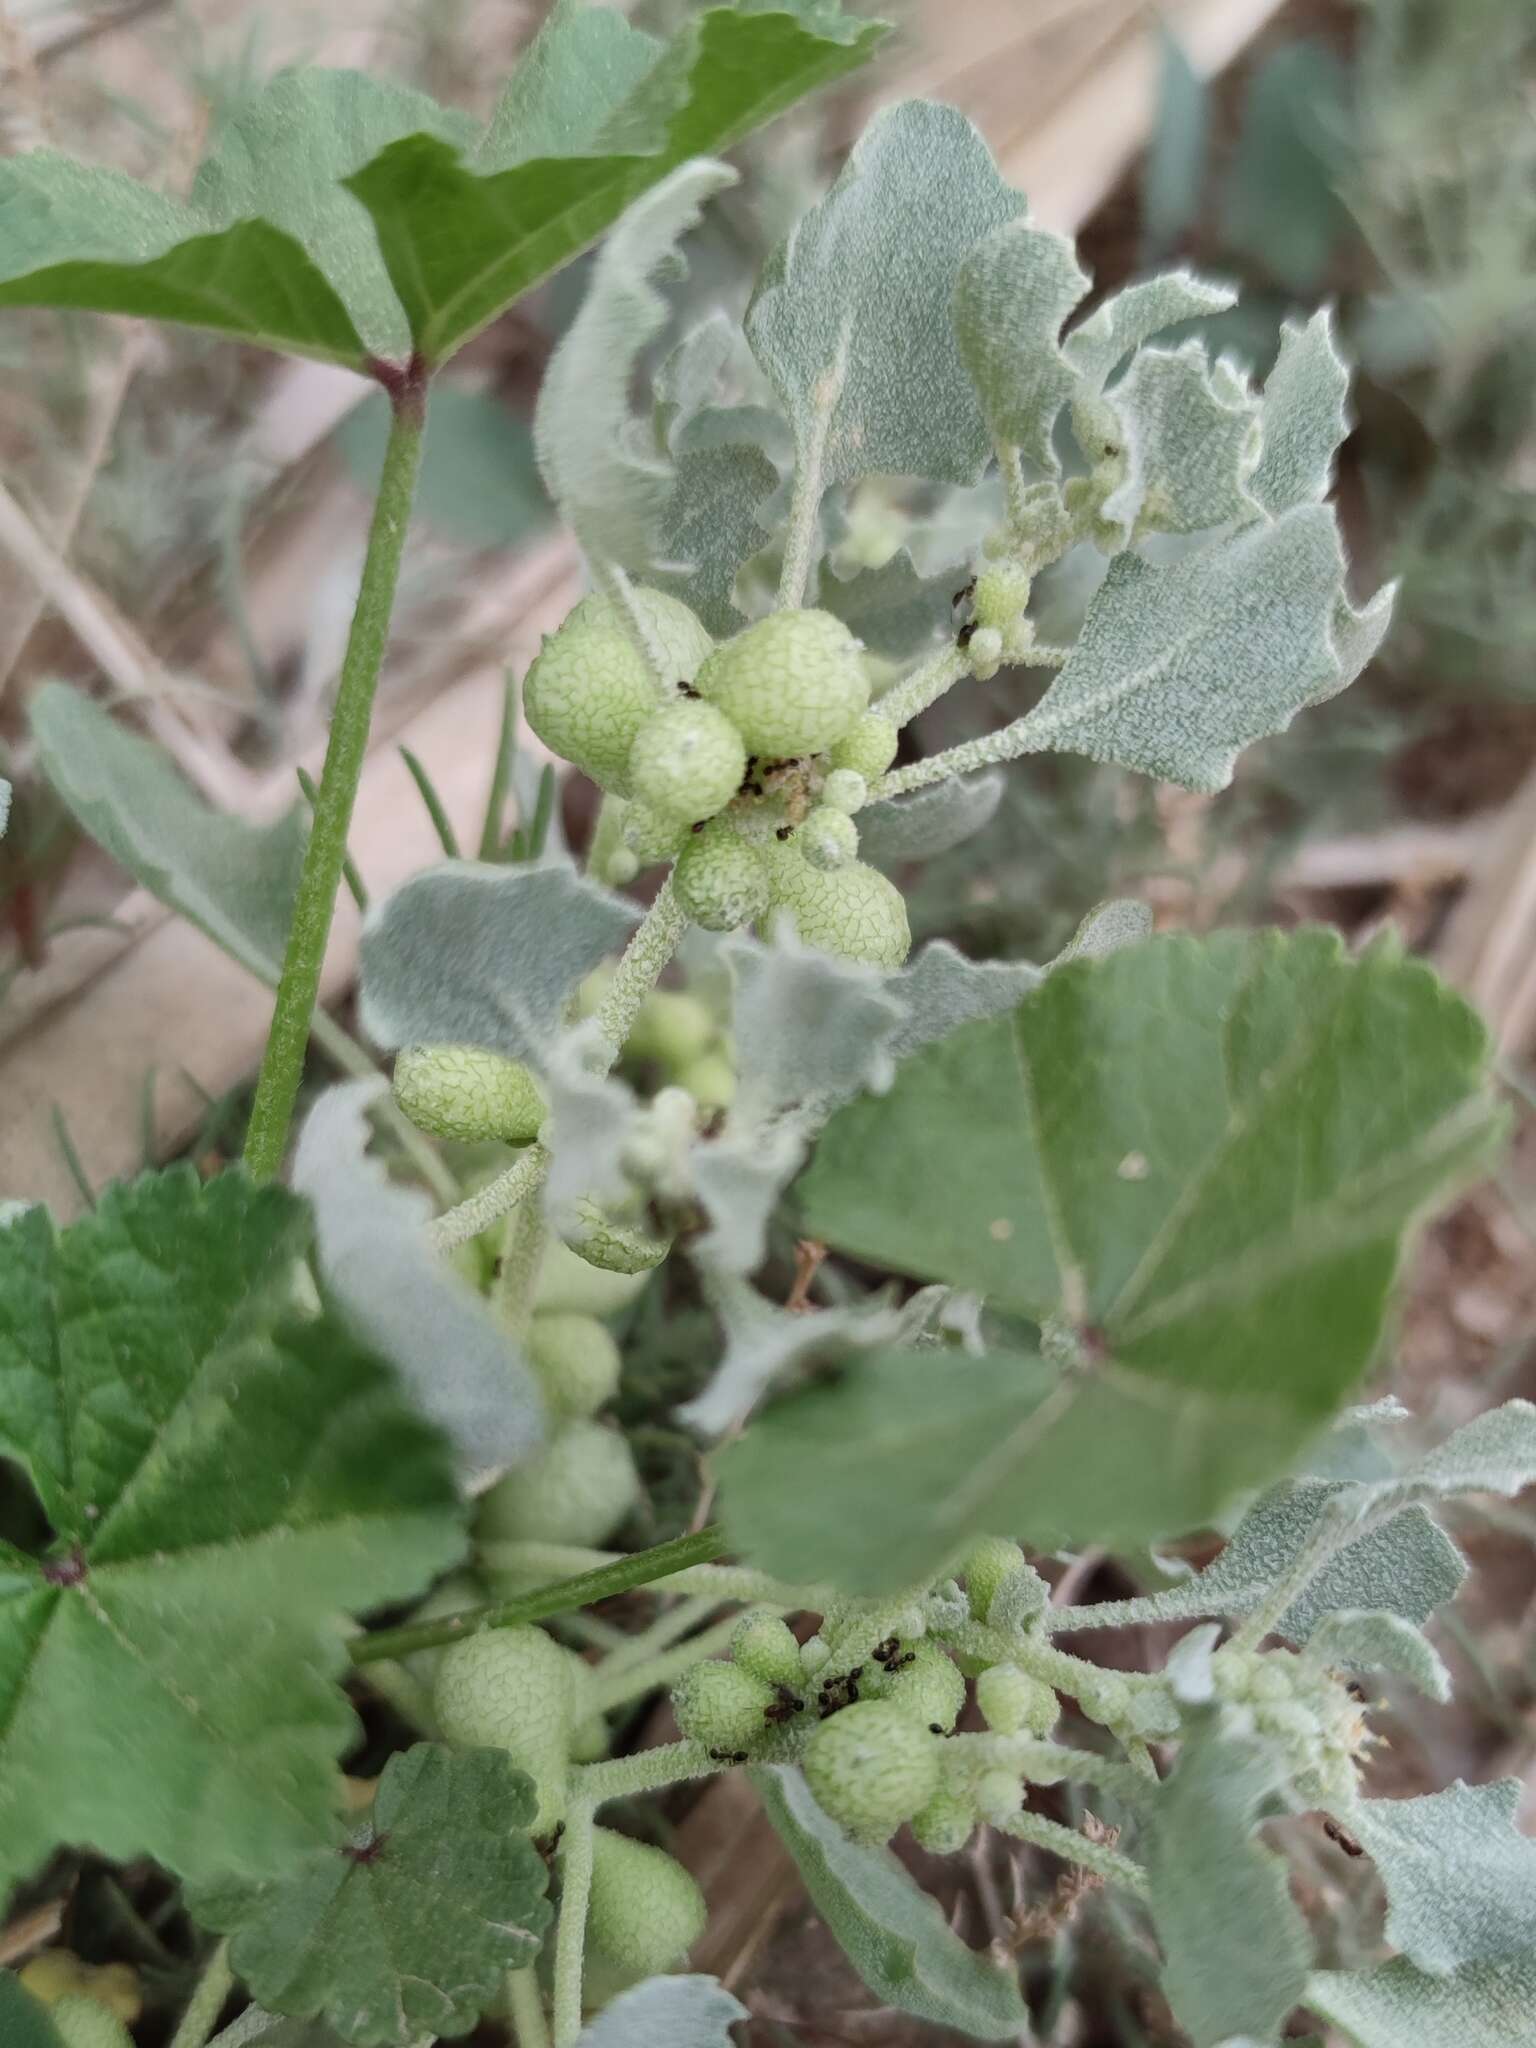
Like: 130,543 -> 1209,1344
0,0 -> 1536,2048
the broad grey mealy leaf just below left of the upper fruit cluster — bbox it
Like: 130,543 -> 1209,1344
360,858 -> 639,1061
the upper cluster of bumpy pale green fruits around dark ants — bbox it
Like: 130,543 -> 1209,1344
524,590 -> 911,967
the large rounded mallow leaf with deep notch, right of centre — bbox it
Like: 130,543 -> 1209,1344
719,930 -> 1501,1581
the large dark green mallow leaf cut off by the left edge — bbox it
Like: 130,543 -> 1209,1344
0,1167 -> 463,1890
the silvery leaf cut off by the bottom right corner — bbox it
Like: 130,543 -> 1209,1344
1307,1950 -> 1536,2048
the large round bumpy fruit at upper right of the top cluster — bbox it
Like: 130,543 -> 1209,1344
698,612 -> 868,766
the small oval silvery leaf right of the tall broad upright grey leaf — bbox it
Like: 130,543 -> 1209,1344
954,219 -> 1087,471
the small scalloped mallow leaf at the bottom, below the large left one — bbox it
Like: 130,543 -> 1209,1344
188,1743 -> 549,2048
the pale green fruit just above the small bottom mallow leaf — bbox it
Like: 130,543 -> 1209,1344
432,1628 -> 575,1835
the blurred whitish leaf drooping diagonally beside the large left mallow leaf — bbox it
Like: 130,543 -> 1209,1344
293,1081 -> 545,1489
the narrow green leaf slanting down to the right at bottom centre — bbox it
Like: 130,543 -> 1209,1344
752,1763 -> 1028,2042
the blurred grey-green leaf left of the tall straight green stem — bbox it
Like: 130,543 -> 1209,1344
32,679 -> 309,987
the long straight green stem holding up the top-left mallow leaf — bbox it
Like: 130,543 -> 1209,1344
246,375 -> 426,1180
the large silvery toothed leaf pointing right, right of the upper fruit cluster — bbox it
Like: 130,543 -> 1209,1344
1016,506 -> 1391,793
